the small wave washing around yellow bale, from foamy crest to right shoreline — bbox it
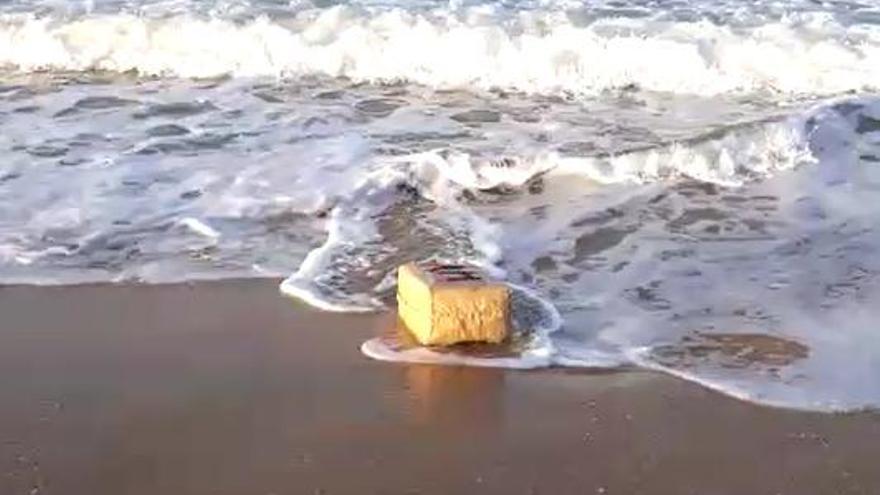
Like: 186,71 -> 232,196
282,99 -> 880,411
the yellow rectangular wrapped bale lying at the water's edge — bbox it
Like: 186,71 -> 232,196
397,263 -> 510,345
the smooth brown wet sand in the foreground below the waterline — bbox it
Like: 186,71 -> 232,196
0,281 -> 880,495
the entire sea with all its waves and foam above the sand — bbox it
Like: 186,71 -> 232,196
0,0 -> 880,411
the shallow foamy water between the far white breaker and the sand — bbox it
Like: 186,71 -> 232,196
0,43 -> 880,410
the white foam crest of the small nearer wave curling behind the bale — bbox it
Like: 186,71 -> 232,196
281,111 -> 812,312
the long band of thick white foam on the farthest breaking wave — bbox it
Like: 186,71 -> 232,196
0,6 -> 880,95
